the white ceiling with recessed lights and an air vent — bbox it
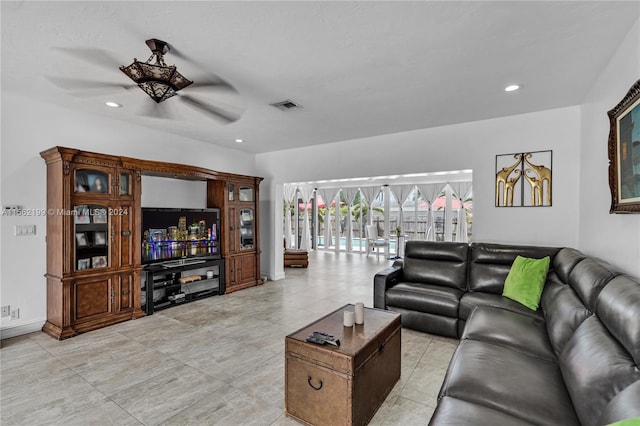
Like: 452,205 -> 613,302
1,0 -> 640,153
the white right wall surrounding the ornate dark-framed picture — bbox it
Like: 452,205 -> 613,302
579,20 -> 640,277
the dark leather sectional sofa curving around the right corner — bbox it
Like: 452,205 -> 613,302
374,241 -> 640,426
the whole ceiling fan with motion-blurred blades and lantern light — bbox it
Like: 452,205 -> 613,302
47,38 -> 242,123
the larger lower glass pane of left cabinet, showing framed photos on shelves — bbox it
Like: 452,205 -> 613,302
73,204 -> 110,271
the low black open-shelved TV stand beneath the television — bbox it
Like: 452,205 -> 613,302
140,259 -> 225,315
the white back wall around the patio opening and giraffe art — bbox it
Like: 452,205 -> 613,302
256,106 -> 580,275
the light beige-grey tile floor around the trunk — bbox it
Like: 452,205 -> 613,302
0,252 -> 457,426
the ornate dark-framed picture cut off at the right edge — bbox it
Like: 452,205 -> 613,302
607,80 -> 640,213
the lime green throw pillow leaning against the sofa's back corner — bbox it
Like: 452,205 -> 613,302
502,256 -> 550,311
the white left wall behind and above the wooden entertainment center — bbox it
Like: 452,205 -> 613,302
0,91 -> 255,337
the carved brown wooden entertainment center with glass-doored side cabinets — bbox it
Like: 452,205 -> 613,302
40,146 -> 263,339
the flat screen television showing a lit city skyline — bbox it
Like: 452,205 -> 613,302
142,207 -> 220,264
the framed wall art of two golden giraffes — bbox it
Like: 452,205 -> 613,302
495,151 -> 553,207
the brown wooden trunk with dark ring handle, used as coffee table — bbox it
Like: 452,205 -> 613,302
285,305 -> 401,426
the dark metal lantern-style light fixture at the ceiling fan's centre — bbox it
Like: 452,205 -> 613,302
120,39 -> 193,103
